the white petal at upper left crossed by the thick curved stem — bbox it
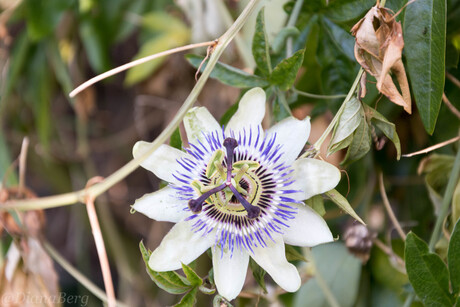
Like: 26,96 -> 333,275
133,141 -> 188,184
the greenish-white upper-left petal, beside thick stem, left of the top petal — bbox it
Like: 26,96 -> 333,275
184,107 -> 222,144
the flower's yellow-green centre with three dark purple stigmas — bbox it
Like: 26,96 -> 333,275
188,138 -> 260,219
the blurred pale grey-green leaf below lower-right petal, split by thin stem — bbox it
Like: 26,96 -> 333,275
292,242 -> 361,307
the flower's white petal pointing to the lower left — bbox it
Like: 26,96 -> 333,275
149,220 -> 214,272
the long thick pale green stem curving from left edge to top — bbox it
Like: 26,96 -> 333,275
0,0 -> 261,210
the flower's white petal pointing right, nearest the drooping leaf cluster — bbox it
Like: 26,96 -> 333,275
290,158 -> 340,200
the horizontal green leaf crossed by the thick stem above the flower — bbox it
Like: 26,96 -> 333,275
185,54 -> 269,88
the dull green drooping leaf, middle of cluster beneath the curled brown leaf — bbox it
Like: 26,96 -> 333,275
341,111 -> 372,165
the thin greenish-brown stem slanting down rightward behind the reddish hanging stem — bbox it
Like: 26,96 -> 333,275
43,242 -> 128,307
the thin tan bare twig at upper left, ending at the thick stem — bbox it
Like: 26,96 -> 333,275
69,41 -> 214,98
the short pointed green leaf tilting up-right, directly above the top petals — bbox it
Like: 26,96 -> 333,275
270,49 -> 305,91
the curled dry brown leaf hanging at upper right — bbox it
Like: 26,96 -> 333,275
351,5 -> 412,114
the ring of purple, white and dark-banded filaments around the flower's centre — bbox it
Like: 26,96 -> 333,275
172,127 -> 299,253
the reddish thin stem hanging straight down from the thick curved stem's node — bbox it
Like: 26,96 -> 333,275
86,177 -> 116,307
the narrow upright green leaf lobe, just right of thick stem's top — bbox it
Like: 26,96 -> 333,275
252,8 -> 272,76
